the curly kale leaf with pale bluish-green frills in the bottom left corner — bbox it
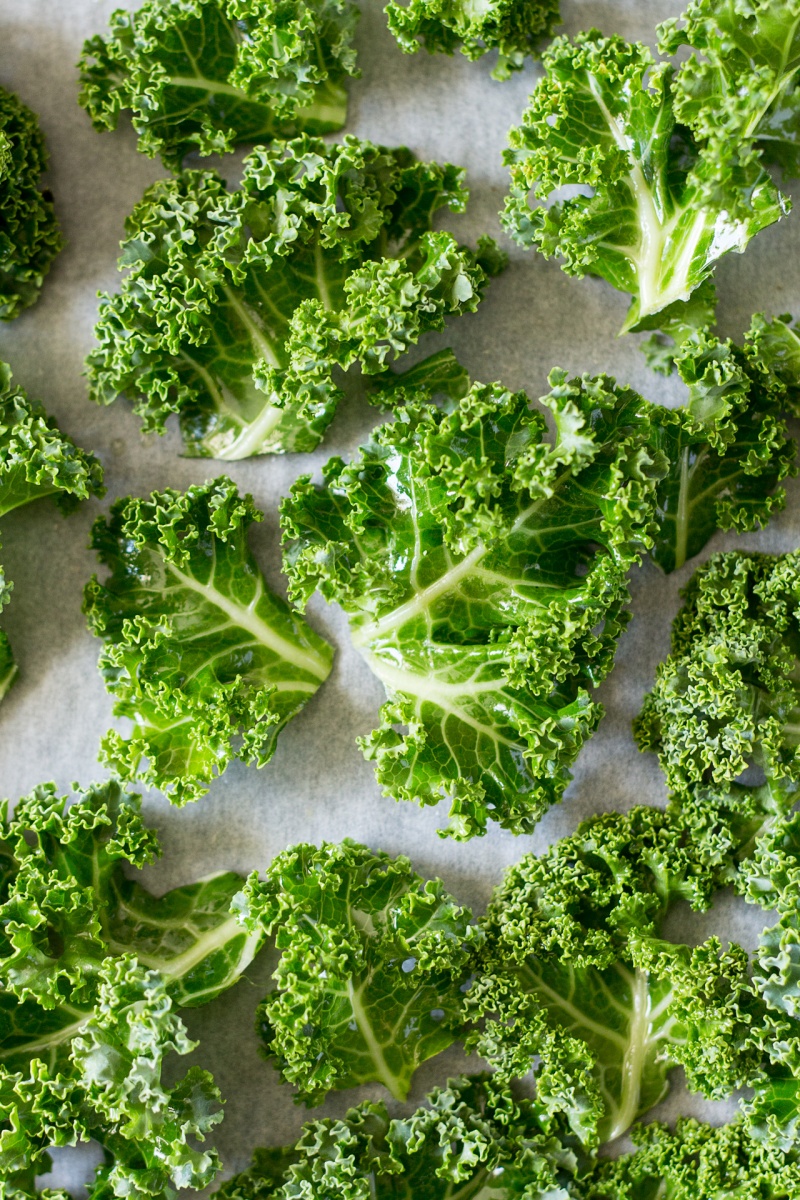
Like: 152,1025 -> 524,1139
0,955 -> 222,1200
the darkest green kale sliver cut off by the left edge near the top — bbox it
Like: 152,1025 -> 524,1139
0,88 -> 64,320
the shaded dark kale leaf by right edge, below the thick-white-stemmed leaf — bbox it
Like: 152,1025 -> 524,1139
650,326 -> 798,571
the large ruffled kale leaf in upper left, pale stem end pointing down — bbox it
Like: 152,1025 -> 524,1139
89,137 -> 504,460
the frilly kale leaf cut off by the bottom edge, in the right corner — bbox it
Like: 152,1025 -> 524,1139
579,1118 -> 800,1200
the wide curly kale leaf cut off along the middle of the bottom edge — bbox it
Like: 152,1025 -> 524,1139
215,1075 -> 582,1200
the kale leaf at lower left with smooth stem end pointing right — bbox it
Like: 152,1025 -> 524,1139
0,781 -> 261,1017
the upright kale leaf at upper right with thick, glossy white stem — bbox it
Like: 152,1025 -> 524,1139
504,32 -> 788,330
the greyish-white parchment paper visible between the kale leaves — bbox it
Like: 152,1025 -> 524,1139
0,0 -> 800,1184
